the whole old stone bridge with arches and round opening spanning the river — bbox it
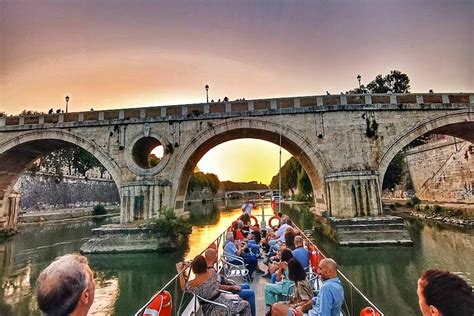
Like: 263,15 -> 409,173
0,93 -> 474,226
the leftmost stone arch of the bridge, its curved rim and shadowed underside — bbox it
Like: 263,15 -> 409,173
0,130 -> 122,222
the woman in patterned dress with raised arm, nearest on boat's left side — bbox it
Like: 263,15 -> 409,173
176,255 -> 250,316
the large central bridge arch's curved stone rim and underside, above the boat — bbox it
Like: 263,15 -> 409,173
173,118 -> 329,208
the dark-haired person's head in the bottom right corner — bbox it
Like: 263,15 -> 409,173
416,270 -> 474,316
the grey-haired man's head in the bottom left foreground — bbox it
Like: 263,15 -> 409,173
36,254 -> 95,315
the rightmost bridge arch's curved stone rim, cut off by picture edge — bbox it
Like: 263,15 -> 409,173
379,110 -> 474,186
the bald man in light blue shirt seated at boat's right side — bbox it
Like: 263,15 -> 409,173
295,258 -> 344,316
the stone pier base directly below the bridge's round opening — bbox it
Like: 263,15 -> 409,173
120,181 -> 171,223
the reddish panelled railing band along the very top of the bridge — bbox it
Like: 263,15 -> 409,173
0,93 -> 474,127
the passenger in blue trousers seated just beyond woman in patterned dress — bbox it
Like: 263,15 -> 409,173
204,249 -> 256,316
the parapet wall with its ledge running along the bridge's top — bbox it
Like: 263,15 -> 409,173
0,93 -> 474,128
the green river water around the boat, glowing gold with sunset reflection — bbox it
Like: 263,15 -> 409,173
0,204 -> 474,315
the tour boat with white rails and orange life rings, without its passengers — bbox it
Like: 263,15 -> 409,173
135,216 -> 384,316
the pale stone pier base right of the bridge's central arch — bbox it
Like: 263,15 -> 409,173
325,171 -> 383,218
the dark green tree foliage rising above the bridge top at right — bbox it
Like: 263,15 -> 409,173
347,70 -> 410,94
